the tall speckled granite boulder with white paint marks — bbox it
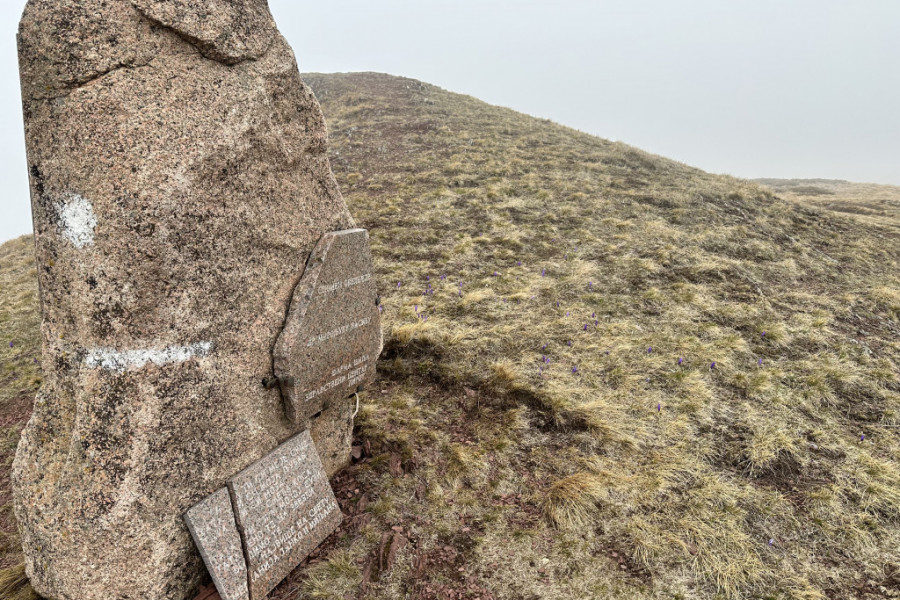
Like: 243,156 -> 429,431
13,0 -> 370,600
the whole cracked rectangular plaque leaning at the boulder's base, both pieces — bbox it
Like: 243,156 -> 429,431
185,431 -> 343,600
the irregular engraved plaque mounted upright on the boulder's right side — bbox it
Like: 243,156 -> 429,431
273,229 -> 382,423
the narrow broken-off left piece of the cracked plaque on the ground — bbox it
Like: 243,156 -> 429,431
184,488 -> 250,600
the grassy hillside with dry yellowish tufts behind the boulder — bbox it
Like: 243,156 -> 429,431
0,73 -> 900,600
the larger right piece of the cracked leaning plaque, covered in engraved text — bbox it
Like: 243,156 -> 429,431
228,431 -> 343,600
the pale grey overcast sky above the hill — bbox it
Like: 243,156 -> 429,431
0,0 -> 900,240
